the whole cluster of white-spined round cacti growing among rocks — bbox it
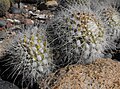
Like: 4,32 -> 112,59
2,0 -> 120,88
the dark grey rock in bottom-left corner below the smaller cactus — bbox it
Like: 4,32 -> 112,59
0,78 -> 19,89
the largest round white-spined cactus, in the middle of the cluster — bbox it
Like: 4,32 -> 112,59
47,0 -> 111,64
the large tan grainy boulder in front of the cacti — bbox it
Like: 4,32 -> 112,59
39,59 -> 120,89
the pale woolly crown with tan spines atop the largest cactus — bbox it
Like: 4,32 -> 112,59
67,12 -> 104,44
